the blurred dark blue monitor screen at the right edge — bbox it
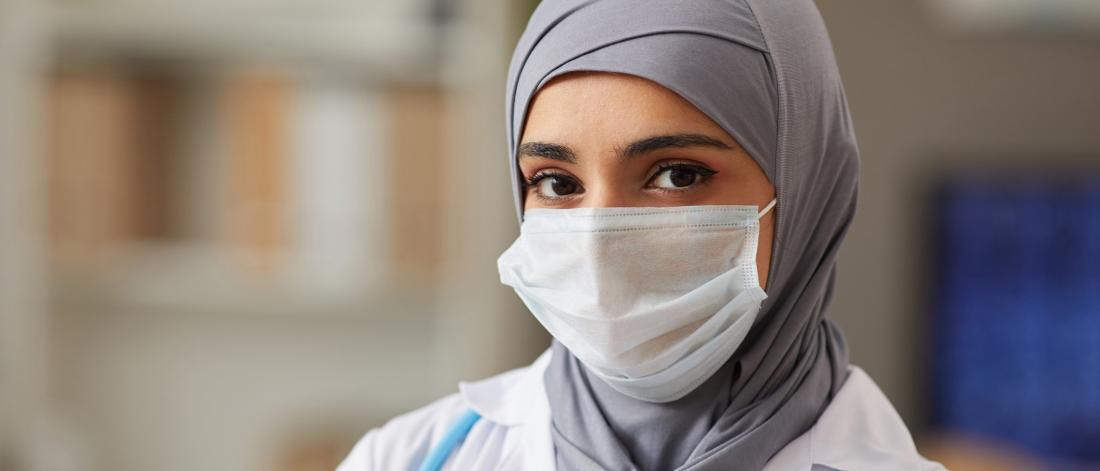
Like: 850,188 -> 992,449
930,175 -> 1100,469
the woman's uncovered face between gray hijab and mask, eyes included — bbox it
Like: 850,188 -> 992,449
518,73 -> 776,285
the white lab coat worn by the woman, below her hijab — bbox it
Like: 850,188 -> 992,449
337,350 -> 944,471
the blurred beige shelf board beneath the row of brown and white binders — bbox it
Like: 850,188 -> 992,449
53,247 -> 436,318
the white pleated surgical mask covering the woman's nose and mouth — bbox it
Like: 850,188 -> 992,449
497,200 -> 776,403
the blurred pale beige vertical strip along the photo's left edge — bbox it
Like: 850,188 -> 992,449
0,0 -> 55,470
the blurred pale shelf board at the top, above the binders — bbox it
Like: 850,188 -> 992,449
47,1 -> 446,75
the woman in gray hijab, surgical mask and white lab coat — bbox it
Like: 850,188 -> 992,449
340,0 -> 942,471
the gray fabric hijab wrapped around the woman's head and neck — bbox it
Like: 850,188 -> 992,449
506,0 -> 858,470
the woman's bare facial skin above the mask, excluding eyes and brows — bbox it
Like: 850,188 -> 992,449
520,73 -> 779,288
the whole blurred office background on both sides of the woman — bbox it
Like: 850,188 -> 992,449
0,0 -> 1100,471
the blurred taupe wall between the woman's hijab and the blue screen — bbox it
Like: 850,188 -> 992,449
817,0 -> 1100,428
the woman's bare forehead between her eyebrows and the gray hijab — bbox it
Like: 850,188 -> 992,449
520,72 -> 733,145
